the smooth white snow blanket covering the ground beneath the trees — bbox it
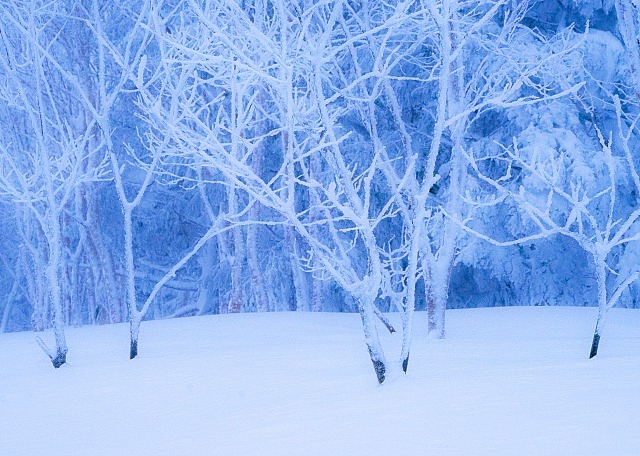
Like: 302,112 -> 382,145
0,307 -> 640,456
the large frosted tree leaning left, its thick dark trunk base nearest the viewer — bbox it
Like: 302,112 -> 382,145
139,2 -> 428,382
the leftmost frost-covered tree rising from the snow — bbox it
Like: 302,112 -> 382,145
0,2 -> 113,367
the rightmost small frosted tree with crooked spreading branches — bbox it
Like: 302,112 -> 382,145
470,95 -> 640,357
